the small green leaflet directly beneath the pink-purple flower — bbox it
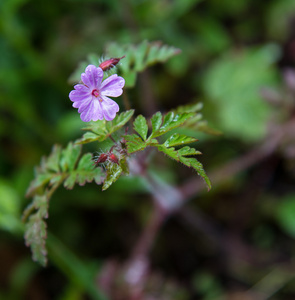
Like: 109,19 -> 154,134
76,109 -> 134,144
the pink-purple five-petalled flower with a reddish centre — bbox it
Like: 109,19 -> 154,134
69,65 -> 125,122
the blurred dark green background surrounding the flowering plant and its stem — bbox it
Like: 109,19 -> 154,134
0,0 -> 295,300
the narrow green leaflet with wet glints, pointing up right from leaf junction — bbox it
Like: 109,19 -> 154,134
149,112 -> 194,138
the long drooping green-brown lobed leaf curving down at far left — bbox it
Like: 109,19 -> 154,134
23,143 -> 103,266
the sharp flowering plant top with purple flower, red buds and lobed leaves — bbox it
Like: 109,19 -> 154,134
23,42 -> 211,274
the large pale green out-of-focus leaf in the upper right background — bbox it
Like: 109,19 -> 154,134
204,45 -> 279,141
